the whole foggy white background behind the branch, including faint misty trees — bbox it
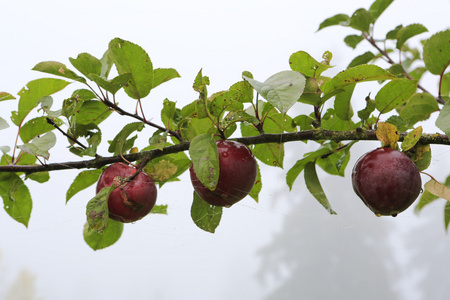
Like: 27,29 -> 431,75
0,0 -> 450,299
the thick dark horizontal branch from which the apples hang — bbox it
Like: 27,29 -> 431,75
0,129 -> 450,174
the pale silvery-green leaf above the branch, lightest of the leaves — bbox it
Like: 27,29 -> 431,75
244,71 -> 306,113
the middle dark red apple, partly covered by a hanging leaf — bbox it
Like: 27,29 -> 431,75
189,140 -> 258,207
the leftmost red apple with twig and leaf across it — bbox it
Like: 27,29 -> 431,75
97,163 -> 157,223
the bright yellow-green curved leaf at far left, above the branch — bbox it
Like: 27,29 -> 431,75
11,78 -> 69,126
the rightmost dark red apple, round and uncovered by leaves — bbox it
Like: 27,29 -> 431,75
352,147 -> 422,217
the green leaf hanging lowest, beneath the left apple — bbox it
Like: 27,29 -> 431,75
83,220 -> 123,251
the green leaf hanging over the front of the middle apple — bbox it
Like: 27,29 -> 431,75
189,134 -> 219,191
